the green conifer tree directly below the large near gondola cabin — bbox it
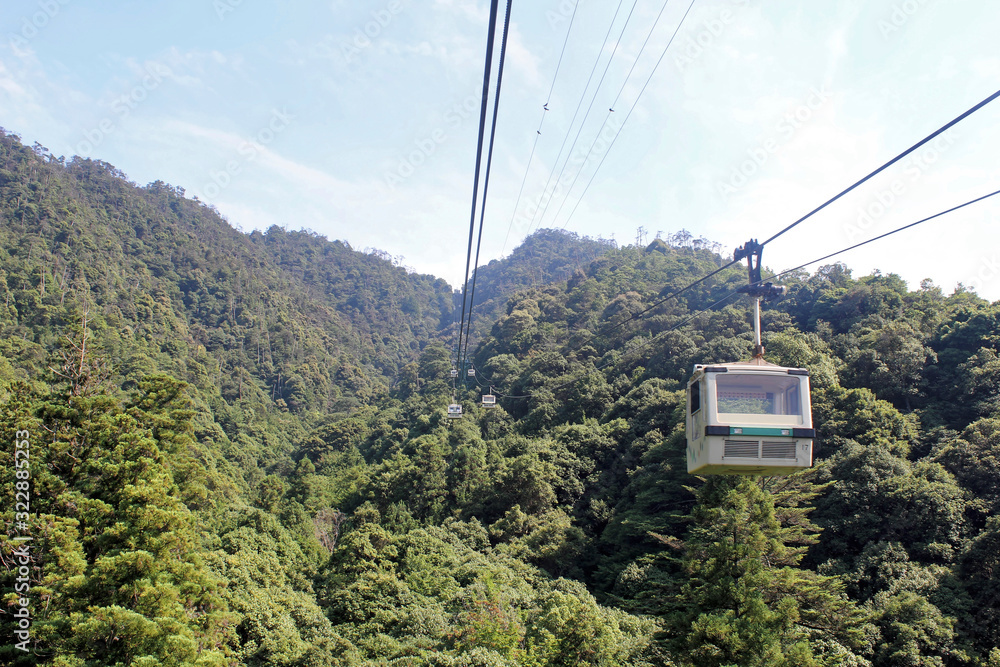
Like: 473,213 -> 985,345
668,477 -> 867,667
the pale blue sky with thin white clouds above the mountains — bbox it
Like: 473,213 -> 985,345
0,0 -> 1000,300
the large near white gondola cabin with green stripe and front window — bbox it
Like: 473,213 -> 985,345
686,359 -> 816,475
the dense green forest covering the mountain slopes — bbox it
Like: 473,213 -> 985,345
0,126 -> 1000,667
